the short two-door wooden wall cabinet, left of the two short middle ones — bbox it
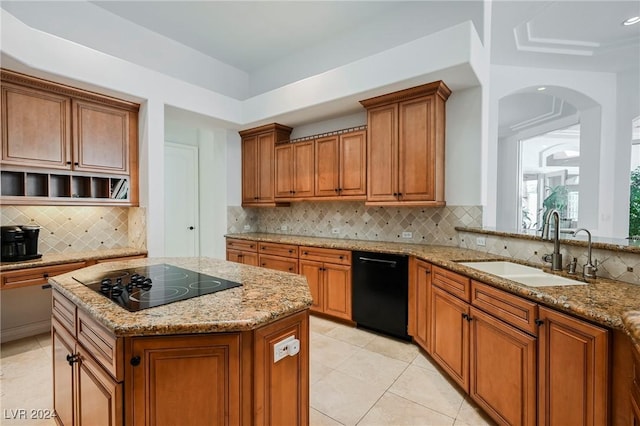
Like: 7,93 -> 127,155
275,141 -> 314,199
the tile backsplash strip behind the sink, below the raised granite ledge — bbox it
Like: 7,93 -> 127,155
458,232 -> 640,284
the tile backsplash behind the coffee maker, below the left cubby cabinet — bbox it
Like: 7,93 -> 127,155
0,206 -> 130,254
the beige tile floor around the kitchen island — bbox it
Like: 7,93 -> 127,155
0,317 -> 492,426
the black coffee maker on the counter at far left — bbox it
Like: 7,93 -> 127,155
0,225 -> 42,262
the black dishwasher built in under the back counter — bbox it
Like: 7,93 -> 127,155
352,251 -> 411,340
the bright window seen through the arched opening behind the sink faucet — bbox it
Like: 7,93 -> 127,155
519,124 -> 580,230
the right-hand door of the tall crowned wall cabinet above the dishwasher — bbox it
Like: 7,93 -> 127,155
398,96 -> 436,201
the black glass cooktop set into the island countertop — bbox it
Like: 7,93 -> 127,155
73,263 -> 242,312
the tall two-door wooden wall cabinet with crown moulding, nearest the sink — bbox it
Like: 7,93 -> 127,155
360,81 -> 451,206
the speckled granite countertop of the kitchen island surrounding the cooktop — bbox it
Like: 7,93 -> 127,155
49,258 -> 312,337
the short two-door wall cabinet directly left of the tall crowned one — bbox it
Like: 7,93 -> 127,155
314,130 -> 367,199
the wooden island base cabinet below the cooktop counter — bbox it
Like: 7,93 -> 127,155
52,290 -> 309,426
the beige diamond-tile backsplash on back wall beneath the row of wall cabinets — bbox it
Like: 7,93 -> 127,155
227,201 -> 482,246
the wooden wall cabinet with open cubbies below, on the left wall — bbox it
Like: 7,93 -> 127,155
0,70 -> 139,205
